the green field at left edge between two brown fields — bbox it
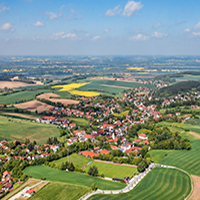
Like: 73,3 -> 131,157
0,90 -> 52,104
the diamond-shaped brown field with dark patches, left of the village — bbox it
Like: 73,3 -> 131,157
14,100 -> 53,113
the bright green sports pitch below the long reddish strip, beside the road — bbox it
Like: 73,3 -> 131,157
84,162 -> 137,178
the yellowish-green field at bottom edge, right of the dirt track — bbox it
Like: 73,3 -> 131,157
30,182 -> 90,200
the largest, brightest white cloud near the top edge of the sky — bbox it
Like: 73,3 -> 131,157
122,1 -> 143,17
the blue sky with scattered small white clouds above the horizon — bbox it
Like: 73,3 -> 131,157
0,0 -> 200,56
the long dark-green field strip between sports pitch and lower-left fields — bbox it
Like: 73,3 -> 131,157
24,165 -> 125,190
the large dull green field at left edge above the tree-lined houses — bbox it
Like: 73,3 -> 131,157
0,117 -> 59,144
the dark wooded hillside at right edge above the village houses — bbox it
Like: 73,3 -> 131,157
155,81 -> 200,97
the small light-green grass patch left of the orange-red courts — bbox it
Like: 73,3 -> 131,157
51,153 -> 92,169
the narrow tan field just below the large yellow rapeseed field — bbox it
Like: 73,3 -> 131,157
37,93 -> 79,106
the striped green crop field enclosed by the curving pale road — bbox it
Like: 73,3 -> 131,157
89,168 -> 191,200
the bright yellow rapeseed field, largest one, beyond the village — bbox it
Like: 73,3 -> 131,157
52,82 -> 100,97
